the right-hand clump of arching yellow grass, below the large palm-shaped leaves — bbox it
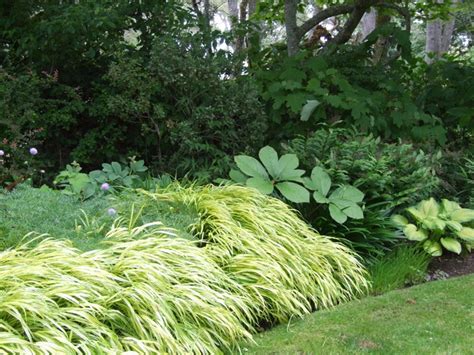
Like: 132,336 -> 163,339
139,185 -> 368,321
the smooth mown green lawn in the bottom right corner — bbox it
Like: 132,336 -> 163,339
246,275 -> 474,354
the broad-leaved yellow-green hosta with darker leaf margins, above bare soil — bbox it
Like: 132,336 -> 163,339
392,198 -> 474,256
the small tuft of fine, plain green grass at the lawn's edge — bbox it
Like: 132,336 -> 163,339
368,245 -> 431,295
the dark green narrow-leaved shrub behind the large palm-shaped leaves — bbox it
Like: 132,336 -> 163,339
286,128 -> 441,209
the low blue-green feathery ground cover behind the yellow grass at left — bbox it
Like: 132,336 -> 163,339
0,185 -> 197,251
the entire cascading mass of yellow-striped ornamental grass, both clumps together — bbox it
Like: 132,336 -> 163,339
0,185 -> 367,354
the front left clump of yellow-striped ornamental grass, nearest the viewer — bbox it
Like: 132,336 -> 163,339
0,227 -> 253,354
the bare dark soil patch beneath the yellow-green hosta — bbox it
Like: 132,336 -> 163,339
428,253 -> 474,280
